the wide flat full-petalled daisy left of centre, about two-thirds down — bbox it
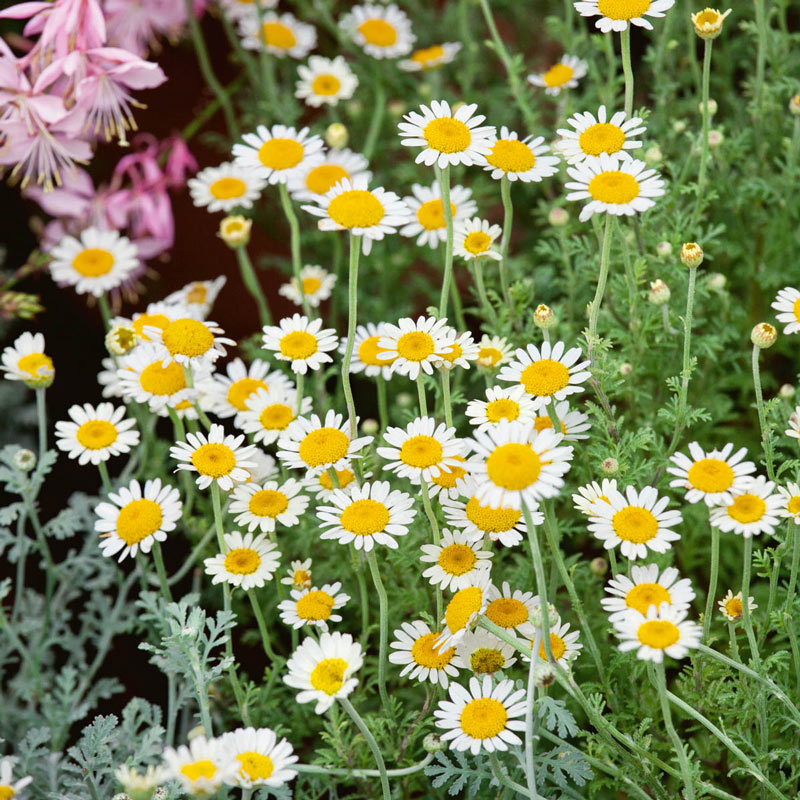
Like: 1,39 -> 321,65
317,481 -> 417,553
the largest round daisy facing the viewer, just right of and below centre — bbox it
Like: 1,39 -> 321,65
469,420 -> 572,511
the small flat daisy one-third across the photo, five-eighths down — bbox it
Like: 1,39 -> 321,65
230,478 -> 309,533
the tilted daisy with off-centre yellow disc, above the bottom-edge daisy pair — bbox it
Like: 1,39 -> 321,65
283,631 -> 364,714
